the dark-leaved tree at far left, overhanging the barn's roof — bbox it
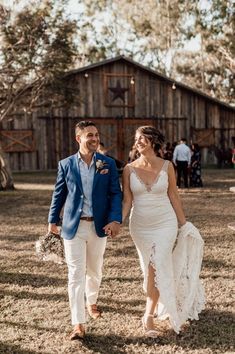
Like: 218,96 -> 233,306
0,0 -> 77,189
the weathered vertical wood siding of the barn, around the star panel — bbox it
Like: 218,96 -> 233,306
0,60 -> 235,170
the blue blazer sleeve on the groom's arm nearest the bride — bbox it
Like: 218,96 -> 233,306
108,159 -> 122,223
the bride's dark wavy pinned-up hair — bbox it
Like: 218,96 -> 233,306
136,125 -> 165,156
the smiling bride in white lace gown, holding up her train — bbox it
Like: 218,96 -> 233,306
123,126 -> 205,337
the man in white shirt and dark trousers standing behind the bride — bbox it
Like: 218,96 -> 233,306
173,138 -> 191,188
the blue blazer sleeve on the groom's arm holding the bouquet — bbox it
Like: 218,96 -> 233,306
48,162 -> 68,224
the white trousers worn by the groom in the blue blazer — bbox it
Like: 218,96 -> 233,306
64,220 -> 107,325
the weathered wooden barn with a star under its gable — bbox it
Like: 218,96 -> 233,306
0,56 -> 235,171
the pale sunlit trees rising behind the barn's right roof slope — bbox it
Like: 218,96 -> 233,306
80,0 -> 235,103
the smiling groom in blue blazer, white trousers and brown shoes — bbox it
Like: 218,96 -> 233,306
48,121 -> 122,340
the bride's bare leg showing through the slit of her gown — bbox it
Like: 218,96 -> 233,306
144,264 -> 159,330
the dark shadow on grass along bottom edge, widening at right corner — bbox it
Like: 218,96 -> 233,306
78,310 -> 234,354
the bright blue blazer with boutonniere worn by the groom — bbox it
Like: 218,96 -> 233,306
48,153 -> 122,240
